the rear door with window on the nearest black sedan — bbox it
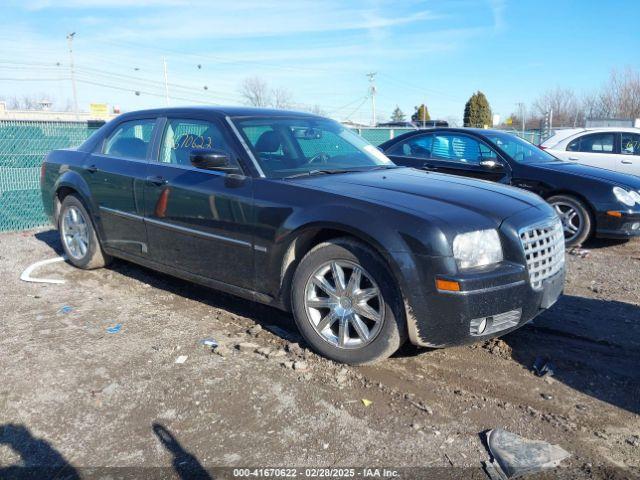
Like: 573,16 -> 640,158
83,118 -> 156,256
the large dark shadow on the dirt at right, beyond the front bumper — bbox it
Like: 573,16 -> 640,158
503,295 -> 640,414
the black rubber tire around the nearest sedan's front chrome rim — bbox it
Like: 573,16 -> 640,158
291,240 -> 406,365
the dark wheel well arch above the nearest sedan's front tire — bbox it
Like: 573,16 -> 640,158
279,228 -> 393,310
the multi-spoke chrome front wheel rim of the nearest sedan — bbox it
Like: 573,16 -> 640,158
304,260 -> 385,348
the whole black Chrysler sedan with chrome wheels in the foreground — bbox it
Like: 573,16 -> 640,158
41,108 -> 565,364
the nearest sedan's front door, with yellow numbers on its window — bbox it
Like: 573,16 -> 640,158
144,118 -> 254,289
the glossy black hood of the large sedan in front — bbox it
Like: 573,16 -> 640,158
290,168 -> 545,228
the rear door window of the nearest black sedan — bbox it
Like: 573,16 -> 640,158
102,119 -> 156,160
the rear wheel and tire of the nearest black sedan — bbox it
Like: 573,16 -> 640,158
58,194 -> 112,270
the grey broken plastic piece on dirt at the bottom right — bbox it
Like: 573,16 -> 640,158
482,428 -> 571,480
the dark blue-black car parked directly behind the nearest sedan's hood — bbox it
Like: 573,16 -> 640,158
380,128 -> 640,245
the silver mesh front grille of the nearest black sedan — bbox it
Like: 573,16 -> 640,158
520,219 -> 564,290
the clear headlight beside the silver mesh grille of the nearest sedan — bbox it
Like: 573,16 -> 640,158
453,230 -> 502,268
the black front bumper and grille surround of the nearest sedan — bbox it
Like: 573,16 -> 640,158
401,207 -> 565,347
